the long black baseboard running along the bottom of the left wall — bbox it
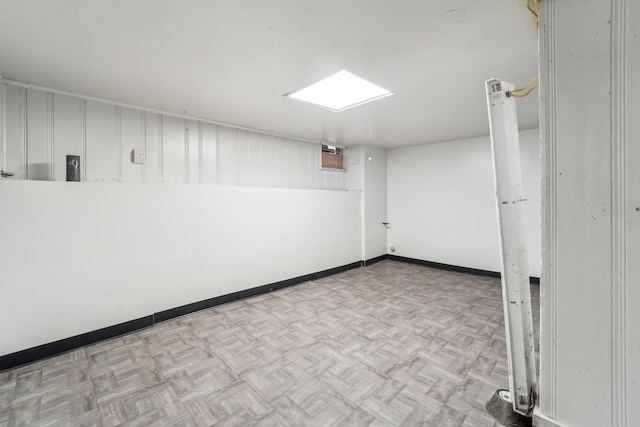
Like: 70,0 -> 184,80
0,261 -> 362,372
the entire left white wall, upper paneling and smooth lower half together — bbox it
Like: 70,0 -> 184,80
0,83 -> 362,354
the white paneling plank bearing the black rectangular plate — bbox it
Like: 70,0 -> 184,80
53,95 -> 82,181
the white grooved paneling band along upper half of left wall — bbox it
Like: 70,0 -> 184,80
2,83 -> 346,190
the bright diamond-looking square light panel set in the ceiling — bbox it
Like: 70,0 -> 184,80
286,70 -> 393,112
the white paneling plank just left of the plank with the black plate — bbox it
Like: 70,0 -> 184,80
26,90 -> 51,181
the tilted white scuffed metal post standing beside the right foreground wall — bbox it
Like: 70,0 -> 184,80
486,79 -> 536,415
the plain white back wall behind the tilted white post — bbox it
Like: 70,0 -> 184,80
387,129 -> 540,277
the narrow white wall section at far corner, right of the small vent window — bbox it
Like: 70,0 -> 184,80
363,146 -> 387,260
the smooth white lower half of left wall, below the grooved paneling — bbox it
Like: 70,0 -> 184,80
0,180 -> 361,355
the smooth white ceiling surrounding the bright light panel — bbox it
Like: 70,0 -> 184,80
0,0 -> 538,148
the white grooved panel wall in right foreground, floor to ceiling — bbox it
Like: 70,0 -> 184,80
538,0 -> 640,427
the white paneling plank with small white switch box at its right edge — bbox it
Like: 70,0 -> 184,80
120,108 -> 146,182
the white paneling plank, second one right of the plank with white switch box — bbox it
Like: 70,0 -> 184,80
162,116 -> 187,183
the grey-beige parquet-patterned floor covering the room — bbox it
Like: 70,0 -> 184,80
0,261 -> 539,427
